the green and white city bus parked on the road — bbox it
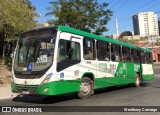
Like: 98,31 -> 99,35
11,26 -> 154,98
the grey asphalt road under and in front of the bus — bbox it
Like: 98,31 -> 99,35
0,70 -> 160,114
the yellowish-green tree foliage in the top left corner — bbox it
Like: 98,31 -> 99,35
0,0 -> 36,41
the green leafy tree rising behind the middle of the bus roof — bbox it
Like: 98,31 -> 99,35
46,0 -> 112,35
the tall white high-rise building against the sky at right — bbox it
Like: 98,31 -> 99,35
132,12 -> 159,37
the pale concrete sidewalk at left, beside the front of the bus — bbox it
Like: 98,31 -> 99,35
0,84 -> 18,99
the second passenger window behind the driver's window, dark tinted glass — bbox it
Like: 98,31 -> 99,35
97,41 -> 110,61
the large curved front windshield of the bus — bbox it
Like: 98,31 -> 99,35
14,29 -> 56,72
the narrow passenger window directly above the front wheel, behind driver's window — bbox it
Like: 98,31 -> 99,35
83,38 -> 95,60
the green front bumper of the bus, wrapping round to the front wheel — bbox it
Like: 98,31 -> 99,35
11,80 -> 80,95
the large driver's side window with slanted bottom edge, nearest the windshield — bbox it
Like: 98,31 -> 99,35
57,39 -> 81,72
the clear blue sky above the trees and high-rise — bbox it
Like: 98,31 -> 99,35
30,0 -> 160,35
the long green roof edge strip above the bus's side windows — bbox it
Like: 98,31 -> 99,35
58,26 -> 152,52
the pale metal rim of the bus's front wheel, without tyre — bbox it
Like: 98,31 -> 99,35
80,82 -> 91,95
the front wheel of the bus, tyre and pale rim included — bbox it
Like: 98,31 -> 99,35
78,77 -> 94,99
